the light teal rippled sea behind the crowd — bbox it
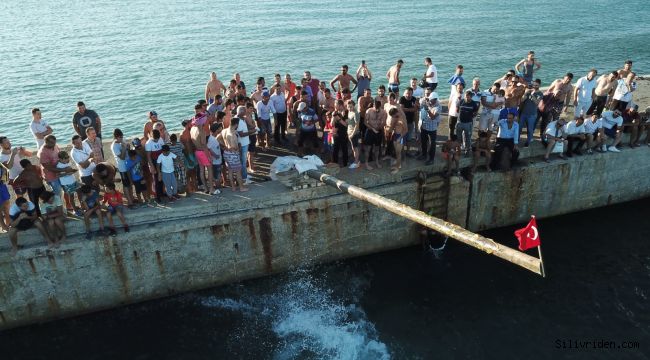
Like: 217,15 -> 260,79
0,0 -> 650,146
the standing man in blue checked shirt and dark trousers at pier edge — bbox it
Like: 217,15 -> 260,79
417,92 -> 442,165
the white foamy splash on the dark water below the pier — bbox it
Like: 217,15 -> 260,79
201,270 -> 391,360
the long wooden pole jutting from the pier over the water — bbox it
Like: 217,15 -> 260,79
306,170 -> 542,275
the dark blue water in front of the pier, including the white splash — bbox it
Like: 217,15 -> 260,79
0,199 -> 650,359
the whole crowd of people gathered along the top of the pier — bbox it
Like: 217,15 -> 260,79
0,51 -> 650,253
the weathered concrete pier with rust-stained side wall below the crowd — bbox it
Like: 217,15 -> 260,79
0,143 -> 650,329
